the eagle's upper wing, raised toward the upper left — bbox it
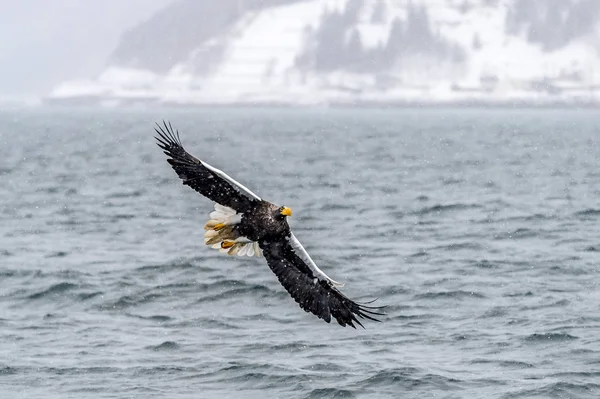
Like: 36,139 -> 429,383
154,121 -> 260,213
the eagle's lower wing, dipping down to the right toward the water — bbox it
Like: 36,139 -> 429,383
260,235 -> 383,328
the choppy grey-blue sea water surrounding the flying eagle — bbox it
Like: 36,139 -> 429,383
0,108 -> 600,399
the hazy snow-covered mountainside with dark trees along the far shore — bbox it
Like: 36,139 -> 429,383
48,0 -> 600,104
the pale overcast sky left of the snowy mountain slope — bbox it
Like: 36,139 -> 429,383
0,0 -> 176,99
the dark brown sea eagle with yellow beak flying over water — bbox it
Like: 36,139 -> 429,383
155,121 -> 383,328
